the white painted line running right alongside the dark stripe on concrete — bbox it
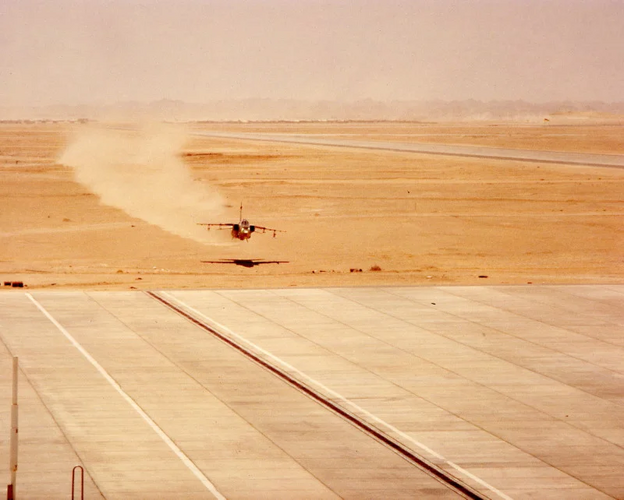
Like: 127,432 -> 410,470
159,292 -> 513,500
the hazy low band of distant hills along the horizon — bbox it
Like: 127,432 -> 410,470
0,99 -> 624,122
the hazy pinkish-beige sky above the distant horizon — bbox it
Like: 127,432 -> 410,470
0,0 -> 624,105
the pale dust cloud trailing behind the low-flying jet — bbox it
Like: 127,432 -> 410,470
59,124 -> 224,245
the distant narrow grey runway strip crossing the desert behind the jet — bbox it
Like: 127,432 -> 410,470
194,131 -> 624,168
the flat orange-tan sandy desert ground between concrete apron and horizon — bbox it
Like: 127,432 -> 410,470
0,123 -> 624,291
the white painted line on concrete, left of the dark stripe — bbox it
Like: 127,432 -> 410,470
26,293 -> 226,500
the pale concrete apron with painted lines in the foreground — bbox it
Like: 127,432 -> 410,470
0,285 -> 624,499
